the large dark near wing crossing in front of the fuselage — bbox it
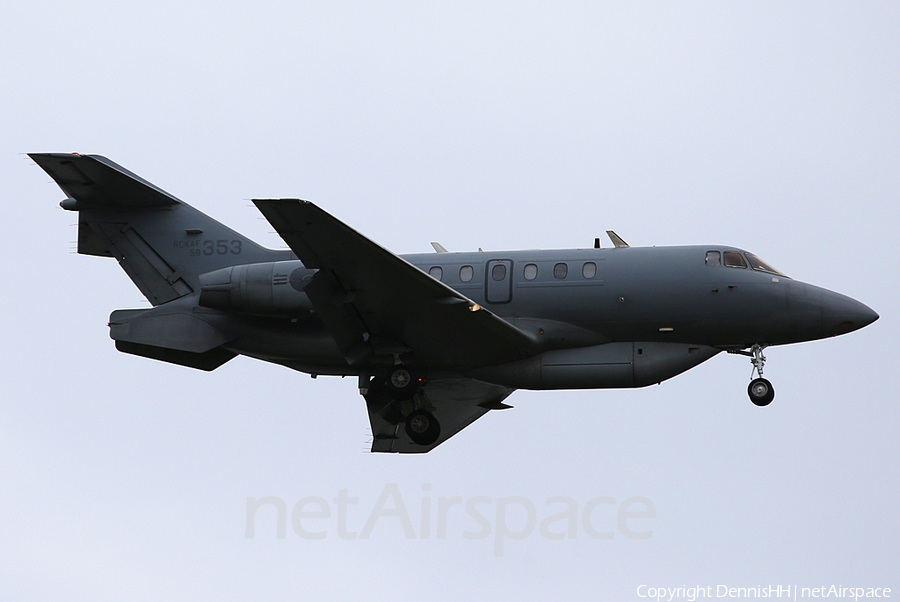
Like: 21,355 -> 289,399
253,199 -> 532,368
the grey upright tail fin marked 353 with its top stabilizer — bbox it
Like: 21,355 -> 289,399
29,153 -> 293,305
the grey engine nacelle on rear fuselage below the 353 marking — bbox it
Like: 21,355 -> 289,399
200,260 -> 316,317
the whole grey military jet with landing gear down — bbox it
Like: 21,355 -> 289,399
30,154 -> 878,453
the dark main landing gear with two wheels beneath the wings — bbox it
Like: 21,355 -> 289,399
366,364 -> 441,446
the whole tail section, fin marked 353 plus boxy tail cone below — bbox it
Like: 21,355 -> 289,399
29,153 -> 293,370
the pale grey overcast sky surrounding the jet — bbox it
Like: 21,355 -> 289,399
0,0 -> 900,600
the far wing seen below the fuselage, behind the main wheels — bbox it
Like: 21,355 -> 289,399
366,378 -> 513,454
